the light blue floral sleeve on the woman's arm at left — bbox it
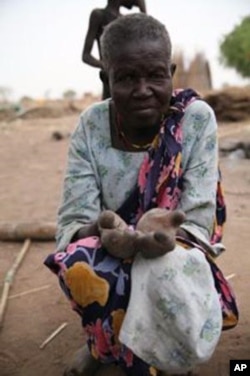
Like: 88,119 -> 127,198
56,111 -> 101,251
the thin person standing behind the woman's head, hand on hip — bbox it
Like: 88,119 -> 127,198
82,0 -> 146,99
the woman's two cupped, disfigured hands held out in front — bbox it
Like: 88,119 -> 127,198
98,208 -> 185,258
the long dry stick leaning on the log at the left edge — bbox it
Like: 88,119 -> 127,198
0,239 -> 31,328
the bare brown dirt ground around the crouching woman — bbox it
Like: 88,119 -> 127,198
0,115 -> 250,376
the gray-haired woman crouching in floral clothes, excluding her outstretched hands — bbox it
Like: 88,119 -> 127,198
45,14 -> 237,376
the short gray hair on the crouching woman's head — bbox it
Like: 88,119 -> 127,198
101,13 -> 172,69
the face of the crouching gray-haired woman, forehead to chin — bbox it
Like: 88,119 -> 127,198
108,41 -> 172,128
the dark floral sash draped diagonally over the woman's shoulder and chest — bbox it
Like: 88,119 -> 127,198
118,89 -> 198,224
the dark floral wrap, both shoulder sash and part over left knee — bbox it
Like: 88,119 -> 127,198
45,91 -> 236,376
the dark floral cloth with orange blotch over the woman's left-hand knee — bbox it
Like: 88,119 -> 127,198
45,237 -> 157,376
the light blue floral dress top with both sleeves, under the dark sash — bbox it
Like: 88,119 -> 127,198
57,95 -> 218,250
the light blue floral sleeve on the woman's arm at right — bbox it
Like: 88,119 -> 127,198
180,100 -> 218,240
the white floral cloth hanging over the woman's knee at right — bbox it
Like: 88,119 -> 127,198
119,245 -> 222,373
